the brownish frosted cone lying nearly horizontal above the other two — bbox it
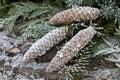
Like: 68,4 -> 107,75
49,7 -> 100,26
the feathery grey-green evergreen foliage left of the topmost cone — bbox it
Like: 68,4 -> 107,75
1,2 -> 56,43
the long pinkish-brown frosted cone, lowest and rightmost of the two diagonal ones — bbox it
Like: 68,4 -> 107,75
46,27 -> 96,73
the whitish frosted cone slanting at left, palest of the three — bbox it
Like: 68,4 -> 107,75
22,27 -> 68,62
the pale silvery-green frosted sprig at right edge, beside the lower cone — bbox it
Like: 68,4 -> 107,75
93,36 -> 120,67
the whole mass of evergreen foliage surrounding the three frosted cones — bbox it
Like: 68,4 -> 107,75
0,0 -> 120,80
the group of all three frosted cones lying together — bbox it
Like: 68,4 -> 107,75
22,7 -> 100,73
